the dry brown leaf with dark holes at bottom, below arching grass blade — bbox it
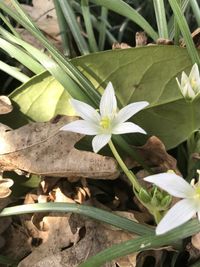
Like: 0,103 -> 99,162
18,214 -> 136,267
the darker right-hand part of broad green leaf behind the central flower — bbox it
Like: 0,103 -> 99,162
72,46 -> 200,149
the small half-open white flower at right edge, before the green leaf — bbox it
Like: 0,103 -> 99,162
176,63 -> 200,101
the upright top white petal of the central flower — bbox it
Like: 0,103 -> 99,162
100,82 -> 117,117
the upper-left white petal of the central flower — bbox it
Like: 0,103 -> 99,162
71,99 -> 100,124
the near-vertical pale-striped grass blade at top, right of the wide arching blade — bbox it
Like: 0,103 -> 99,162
153,0 -> 169,39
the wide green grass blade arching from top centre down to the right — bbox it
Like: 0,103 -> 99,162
90,0 -> 158,41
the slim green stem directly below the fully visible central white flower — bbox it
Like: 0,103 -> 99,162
108,140 -> 141,192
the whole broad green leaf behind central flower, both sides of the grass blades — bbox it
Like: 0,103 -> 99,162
11,46 -> 200,149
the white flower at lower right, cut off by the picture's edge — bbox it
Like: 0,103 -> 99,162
144,173 -> 200,235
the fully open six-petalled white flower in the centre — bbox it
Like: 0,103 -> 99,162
61,82 -> 149,153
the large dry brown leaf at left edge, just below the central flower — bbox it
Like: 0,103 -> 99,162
0,116 -> 119,179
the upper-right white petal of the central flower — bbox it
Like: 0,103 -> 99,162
115,101 -> 149,123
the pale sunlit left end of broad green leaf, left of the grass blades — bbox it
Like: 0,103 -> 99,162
10,72 -> 74,121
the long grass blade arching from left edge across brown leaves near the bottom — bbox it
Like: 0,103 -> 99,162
0,202 -> 154,235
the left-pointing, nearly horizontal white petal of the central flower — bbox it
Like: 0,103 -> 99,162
60,120 -> 99,135
